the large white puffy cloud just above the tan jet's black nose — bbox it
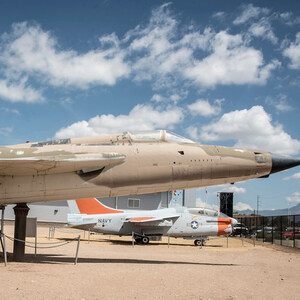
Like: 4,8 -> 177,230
197,106 -> 300,154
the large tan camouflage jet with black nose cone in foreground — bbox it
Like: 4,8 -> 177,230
0,130 -> 300,204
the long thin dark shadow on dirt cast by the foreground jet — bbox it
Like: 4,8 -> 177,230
1,253 -> 238,267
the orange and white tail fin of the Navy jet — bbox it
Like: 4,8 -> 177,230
68,198 -> 124,215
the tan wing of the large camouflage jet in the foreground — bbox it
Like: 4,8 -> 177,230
0,147 -> 126,175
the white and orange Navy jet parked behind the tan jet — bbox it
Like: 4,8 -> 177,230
68,198 -> 237,245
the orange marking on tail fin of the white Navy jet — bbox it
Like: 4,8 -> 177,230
75,198 -> 124,215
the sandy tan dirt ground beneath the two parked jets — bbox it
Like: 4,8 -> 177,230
0,224 -> 300,299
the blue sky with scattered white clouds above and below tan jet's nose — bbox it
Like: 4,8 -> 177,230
0,0 -> 300,209
